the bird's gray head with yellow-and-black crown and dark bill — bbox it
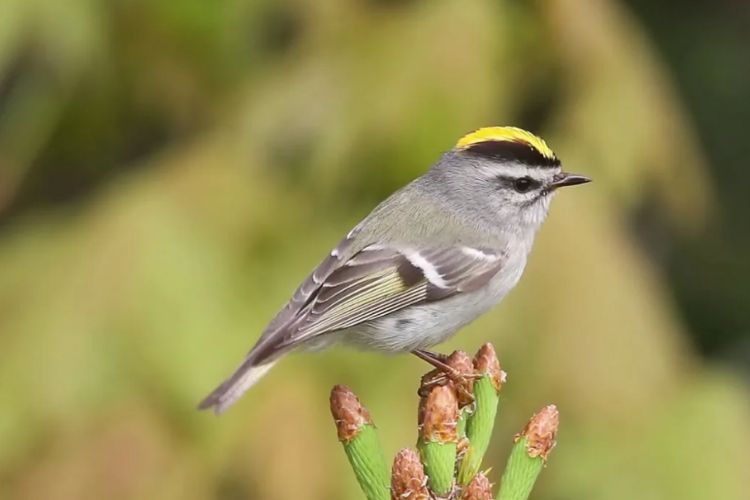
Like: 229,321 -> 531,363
425,127 -> 590,231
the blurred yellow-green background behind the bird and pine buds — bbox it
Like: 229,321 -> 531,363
0,0 -> 750,500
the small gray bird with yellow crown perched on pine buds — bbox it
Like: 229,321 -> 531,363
199,127 -> 590,414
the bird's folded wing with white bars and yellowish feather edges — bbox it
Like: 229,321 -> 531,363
262,245 -> 504,354
